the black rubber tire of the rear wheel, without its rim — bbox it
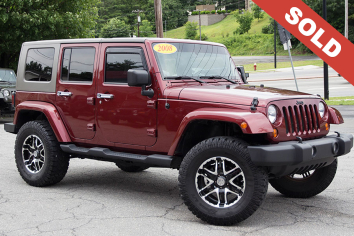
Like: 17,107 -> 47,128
15,120 -> 69,187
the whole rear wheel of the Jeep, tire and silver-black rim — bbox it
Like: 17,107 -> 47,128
15,121 -> 69,187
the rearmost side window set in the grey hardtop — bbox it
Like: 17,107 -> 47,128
25,48 -> 55,81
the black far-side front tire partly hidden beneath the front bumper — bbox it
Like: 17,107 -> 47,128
269,159 -> 337,198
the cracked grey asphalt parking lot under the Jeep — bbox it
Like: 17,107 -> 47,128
0,106 -> 354,236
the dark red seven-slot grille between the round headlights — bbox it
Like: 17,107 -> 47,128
283,105 -> 321,135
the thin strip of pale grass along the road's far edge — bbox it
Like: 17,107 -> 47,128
244,60 -> 323,73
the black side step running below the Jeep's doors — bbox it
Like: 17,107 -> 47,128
60,144 -> 178,168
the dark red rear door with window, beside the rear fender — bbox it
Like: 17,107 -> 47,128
56,44 -> 99,141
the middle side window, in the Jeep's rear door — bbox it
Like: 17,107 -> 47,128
61,47 -> 96,82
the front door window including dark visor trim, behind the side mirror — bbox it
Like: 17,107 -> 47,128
104,48 -> 147,84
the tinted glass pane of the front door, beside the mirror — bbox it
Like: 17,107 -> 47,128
105,50 -> 144,83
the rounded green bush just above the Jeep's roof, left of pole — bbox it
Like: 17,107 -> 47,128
100,18 -> 130,38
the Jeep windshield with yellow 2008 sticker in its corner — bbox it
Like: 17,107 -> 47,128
153,43 -> 241,80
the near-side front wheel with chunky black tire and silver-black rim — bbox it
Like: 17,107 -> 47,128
178,137 -> 268,225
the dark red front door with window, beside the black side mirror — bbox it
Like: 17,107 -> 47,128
96,43 -> 157,146
